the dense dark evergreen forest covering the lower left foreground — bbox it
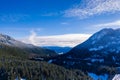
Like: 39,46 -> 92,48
0,53 -> 92,80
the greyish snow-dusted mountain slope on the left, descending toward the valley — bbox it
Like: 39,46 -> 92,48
0,34 -> 56,56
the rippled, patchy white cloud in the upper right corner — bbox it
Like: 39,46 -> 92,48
64,0 -> 120,19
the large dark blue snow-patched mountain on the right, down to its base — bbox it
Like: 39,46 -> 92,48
52,28 -> 120,74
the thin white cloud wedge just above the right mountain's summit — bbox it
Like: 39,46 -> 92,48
94,20 -> 120,28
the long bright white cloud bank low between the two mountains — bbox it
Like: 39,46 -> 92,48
23,31 -> 91,47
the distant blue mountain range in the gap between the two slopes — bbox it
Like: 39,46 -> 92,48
43,46 -> 72,54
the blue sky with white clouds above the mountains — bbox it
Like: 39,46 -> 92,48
0,0 -> 120,47
